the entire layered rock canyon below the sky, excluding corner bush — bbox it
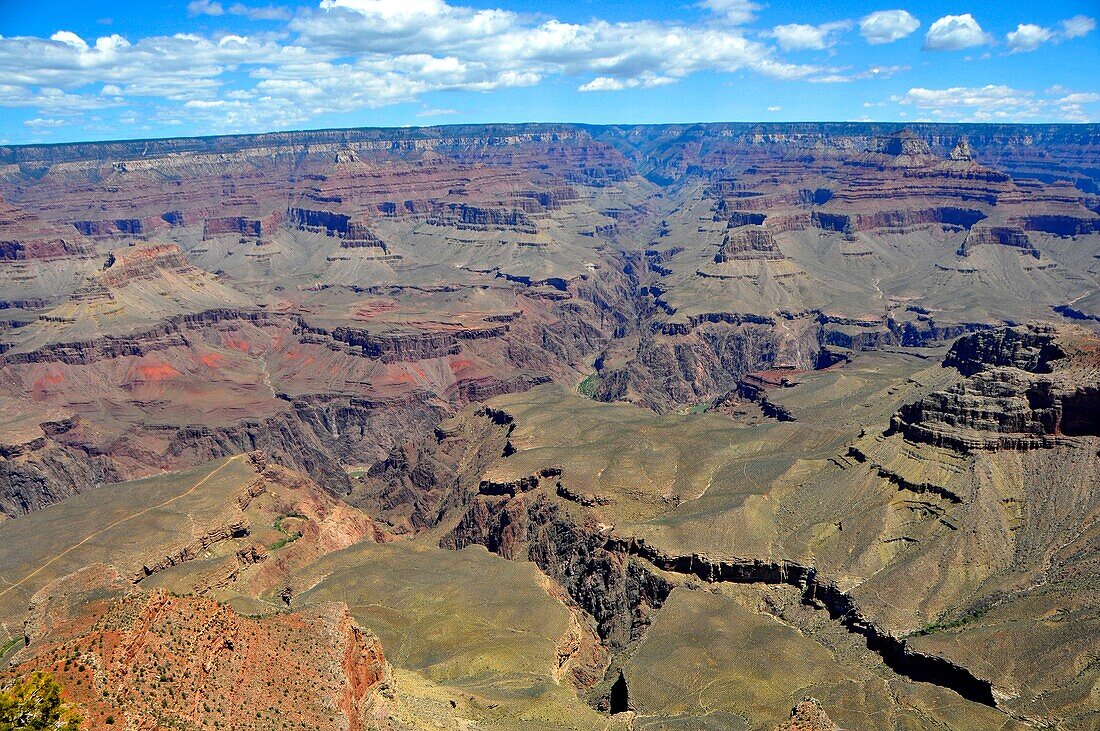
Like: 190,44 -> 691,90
0,123 -> 1100,731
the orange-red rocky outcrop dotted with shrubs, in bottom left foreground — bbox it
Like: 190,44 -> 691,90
3,566 -> 393,731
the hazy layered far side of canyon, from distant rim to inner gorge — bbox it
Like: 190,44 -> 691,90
0,123 -> 1100,507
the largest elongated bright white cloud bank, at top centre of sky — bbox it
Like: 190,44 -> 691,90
290,0 -> 816,91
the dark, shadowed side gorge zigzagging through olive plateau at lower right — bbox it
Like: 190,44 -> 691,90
440,461 -> 996,706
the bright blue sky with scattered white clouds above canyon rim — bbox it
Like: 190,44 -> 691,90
0,0 -> 1100,144
